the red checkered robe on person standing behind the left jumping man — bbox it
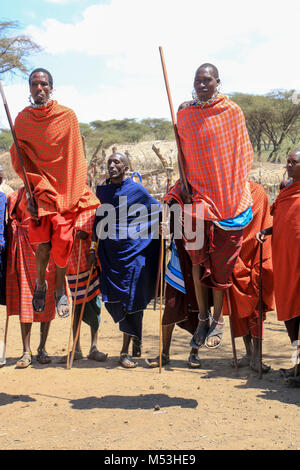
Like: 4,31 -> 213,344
6,188 -> 55,323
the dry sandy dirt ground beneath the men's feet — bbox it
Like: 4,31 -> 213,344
0,307 -> 300,450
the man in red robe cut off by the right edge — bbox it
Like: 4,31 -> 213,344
257,150 -> 300,387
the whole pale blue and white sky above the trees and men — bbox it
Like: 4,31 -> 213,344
0,0 -> 300,127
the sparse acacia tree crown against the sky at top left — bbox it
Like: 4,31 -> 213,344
0,21 -> 41,74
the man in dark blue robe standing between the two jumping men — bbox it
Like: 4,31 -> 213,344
89,153 -> 161,368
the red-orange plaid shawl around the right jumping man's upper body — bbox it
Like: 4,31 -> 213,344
165,95 -> 253,220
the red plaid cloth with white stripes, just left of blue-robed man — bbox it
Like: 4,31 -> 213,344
67,209 -> 100,305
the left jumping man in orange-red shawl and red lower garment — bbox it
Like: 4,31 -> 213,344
11,69 -> 99,318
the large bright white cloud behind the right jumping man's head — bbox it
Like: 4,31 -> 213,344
8,0 -> 300,120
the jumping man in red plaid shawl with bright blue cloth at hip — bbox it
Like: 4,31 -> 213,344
165,64 -> 253,349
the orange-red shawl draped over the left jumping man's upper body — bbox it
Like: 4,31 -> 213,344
11,101 -> 99,217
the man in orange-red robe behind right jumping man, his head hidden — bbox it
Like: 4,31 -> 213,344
223,181 -> 275,372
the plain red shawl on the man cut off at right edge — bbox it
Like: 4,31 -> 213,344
271,181 -> 300,321
